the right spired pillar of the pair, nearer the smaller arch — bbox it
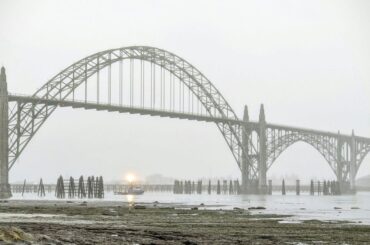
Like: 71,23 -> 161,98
258,104 -> 267,194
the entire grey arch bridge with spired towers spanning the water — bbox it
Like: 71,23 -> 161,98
0,46 -> 370,197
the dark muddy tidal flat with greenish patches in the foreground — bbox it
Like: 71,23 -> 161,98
0,201 -> 370,244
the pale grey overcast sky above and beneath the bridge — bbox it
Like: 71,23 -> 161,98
0,0 -> 370,183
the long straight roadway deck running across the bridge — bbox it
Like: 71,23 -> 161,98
8,93 -> 370,143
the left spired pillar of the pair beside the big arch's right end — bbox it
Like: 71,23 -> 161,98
241,106 -> 249,194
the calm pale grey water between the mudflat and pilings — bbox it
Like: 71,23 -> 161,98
8,192 -> 370,224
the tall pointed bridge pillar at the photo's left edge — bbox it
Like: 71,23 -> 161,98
0,67 -> 12,199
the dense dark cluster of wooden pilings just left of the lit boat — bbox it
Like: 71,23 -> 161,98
55,175 -> 104,199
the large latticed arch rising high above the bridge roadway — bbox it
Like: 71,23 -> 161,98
8,46 -> 251,172
